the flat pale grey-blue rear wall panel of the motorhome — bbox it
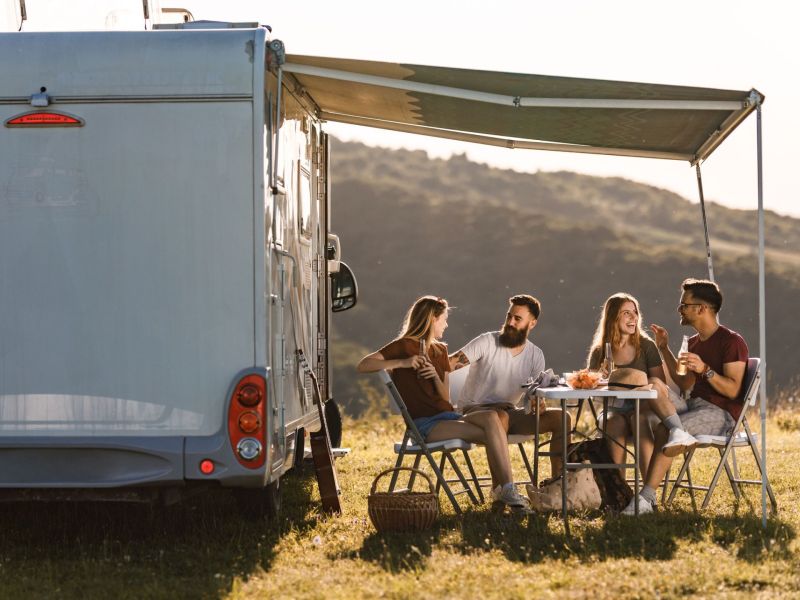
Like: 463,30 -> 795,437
0,31 -> 263,436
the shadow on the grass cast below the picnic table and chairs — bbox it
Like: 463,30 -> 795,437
346,510 -> 797,573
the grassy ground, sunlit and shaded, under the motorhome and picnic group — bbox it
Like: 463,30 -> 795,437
0,412 -> 800,600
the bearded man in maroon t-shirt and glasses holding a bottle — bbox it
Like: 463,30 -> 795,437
623,279 -> 748,515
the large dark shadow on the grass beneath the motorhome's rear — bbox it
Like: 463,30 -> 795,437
0,469 -> 324,600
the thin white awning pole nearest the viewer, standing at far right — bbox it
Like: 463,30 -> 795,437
756,102 -> 767,529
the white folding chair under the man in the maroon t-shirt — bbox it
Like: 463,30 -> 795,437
666,358 -> 778,512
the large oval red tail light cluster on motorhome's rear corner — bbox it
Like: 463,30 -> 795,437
228,374 -> 267,469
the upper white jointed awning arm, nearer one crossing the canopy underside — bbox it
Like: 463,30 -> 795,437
283,62 -> 747,111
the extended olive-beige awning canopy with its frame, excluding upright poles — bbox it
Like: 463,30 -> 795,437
282,55 -> 764,163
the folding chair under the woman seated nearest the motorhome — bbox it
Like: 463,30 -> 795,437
378,370 -> 483,514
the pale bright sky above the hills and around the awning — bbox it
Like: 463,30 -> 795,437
14,0 -> 800,219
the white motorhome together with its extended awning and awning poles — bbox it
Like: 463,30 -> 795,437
0,0 -> 767,524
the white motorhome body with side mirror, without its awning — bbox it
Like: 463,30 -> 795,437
0,3 -> 356,511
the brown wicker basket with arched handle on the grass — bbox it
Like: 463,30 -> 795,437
367,467 -> 439,532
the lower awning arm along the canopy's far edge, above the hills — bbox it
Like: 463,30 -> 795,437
320,111 -> 692,161
